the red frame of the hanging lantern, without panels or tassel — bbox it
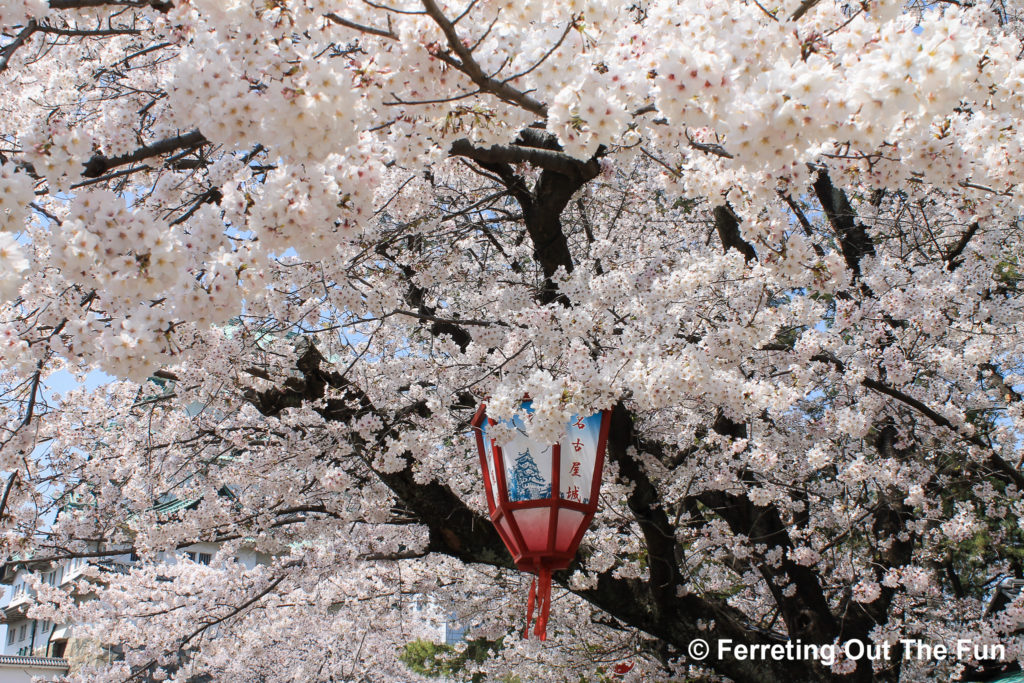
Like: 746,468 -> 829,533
470,398 -> 611,574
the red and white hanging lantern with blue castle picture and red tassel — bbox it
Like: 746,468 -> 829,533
472,400 -> 611,640
